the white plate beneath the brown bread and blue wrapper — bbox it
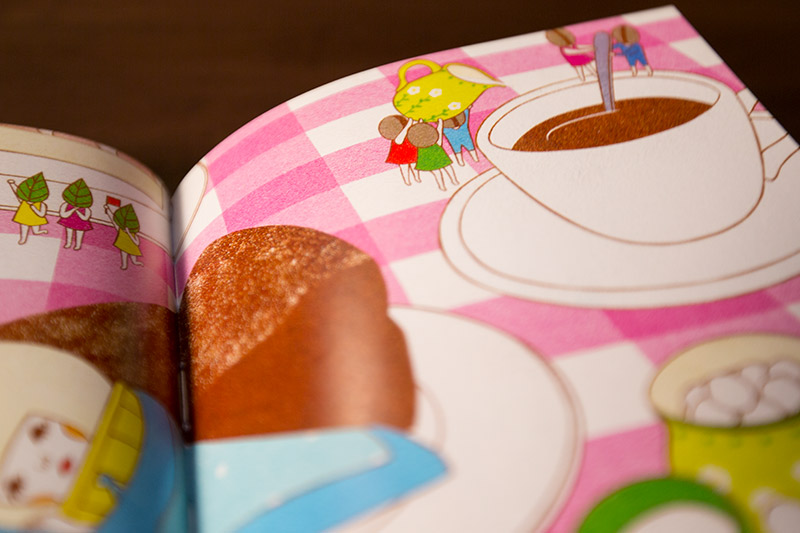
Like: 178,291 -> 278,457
342,307 -> 583,533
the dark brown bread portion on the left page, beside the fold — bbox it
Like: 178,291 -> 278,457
0,302 -> 179,420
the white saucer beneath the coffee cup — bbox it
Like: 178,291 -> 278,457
440,152 -> 800,308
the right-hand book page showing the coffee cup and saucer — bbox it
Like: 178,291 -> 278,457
173,7 -> 800,532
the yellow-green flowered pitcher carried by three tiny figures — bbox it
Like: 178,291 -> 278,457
394,59 -> 504,122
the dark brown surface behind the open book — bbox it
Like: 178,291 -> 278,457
0,0 -> 800,190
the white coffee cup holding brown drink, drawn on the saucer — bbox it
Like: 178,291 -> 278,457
476,71 -> 764,244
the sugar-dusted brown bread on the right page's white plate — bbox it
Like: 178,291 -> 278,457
180,226 -> 414,440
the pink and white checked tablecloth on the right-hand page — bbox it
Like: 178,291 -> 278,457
170,8 -> 800,531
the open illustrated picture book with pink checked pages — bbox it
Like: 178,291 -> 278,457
0,7 -> 800,532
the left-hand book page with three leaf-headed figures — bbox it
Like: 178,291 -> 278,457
0,125 -> 186,531
